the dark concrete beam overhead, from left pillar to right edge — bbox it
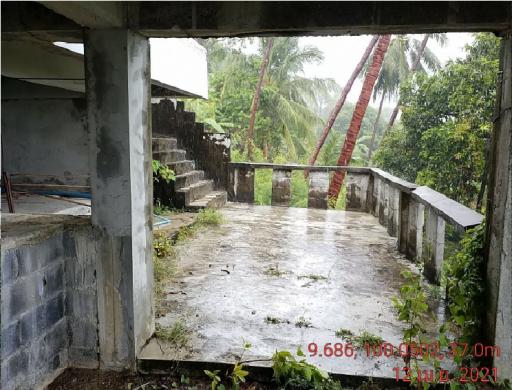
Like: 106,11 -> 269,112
133,1 -> 511,38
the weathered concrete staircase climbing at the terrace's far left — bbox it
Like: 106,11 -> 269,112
153,136 -> 227,209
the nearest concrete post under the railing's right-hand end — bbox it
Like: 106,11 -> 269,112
423,208 -> 445,284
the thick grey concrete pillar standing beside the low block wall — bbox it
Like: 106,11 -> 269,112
85,29 -> 154,369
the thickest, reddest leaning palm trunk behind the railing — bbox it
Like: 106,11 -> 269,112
329,35 -> 391,204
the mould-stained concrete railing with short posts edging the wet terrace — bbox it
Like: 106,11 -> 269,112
228,163 -> 483,283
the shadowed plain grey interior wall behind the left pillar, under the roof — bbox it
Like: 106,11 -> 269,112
2,83 -> 89,186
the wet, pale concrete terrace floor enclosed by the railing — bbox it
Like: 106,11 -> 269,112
140,204 -> 440,377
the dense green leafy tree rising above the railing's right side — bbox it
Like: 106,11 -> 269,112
374,33 -> 499,206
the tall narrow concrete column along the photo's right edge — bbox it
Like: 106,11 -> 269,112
483,35 -> 512,379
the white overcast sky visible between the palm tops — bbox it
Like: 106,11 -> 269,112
299,33 -> 473,107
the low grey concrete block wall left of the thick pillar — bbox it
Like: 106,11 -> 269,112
0,217 -> 98,390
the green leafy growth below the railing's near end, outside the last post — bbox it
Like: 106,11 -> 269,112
443,224 -> 485,345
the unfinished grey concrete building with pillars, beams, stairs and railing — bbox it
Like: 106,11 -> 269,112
1,2 -> 512,389
